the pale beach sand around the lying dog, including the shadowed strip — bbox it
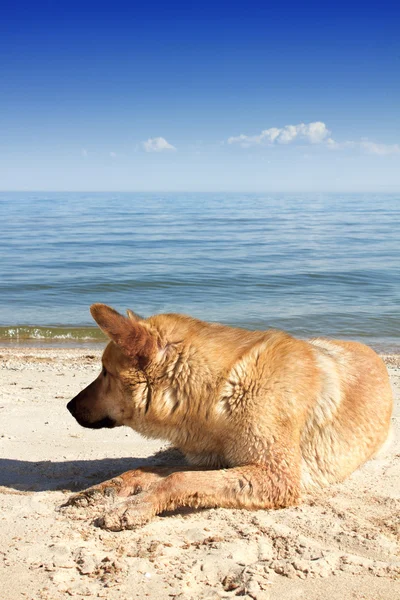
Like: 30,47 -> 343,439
0,348 -> 400,600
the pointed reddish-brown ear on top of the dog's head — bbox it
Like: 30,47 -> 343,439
90,304 -> 157,361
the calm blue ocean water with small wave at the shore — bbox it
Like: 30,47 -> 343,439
0,192 -> 400,350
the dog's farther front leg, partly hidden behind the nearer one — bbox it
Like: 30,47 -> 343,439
64,466 -> 206,507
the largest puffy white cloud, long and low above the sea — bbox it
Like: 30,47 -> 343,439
228,121 -> 331,148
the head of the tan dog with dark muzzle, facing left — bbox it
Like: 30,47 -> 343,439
67,304 -> 163,429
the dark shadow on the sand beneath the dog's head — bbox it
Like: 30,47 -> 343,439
0,448 -> 186,492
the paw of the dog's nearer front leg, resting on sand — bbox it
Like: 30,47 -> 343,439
96,499 -> 155,531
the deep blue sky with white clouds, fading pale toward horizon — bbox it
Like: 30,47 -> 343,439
0,0 -> 400,192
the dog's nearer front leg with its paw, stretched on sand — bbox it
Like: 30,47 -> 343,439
99,463 -> 300,531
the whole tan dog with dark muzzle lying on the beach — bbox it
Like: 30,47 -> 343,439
68,304 -> 393,531
